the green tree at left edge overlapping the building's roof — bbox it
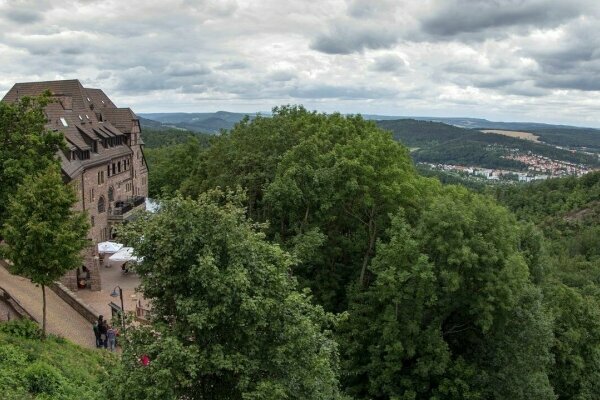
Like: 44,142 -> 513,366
0,94 -> 64,228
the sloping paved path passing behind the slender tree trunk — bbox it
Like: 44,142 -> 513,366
0,260 -> 96,348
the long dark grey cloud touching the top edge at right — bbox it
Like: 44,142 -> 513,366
421,0 -> 594,37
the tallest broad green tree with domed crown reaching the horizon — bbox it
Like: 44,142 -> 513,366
183,106 -> 437,311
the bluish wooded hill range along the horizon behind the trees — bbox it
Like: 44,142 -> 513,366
141,111 -> 600,169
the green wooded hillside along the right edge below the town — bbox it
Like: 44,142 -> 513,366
496,172 -> 600,399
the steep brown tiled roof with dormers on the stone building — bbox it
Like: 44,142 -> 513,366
2,79 -> 137,178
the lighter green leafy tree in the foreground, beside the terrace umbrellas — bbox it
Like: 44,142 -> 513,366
110,192 -> 339,400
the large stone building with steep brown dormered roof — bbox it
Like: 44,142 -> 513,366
2,80 -> 148,290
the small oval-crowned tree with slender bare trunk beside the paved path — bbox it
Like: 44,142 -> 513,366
2,165 -> 89,336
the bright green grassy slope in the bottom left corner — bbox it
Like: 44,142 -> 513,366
0,321 -> 114,400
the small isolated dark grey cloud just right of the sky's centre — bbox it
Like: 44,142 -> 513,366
310,23 -> 398,54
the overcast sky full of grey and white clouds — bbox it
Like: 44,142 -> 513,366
0,0 -> 600,127
